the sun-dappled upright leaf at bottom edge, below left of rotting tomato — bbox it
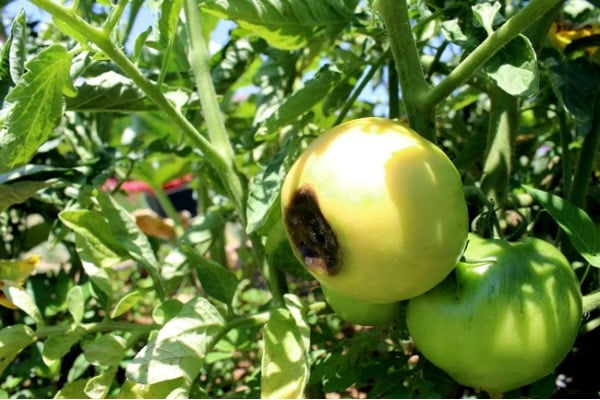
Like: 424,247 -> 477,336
261,302 -> 310,399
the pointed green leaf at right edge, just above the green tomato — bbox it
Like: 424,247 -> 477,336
524,186 -> 600,267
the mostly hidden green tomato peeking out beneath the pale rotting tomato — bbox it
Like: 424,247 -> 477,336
321,285 -> 402,325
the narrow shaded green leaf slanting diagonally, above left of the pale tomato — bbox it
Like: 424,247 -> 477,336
255,65 -> 344,140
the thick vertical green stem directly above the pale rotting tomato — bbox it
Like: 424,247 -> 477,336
379,0 -> 436,141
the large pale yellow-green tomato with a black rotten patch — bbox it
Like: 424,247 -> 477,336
281,118 -> 468,303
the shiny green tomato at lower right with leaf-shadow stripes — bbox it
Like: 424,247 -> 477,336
406,235 -> 582,393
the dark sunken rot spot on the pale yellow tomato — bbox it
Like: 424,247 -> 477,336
283,185 -> 342,275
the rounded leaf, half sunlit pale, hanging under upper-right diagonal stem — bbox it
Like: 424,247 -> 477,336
483,35 -> 539,97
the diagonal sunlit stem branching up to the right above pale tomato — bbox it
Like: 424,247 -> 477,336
421,0 -> 562,110
